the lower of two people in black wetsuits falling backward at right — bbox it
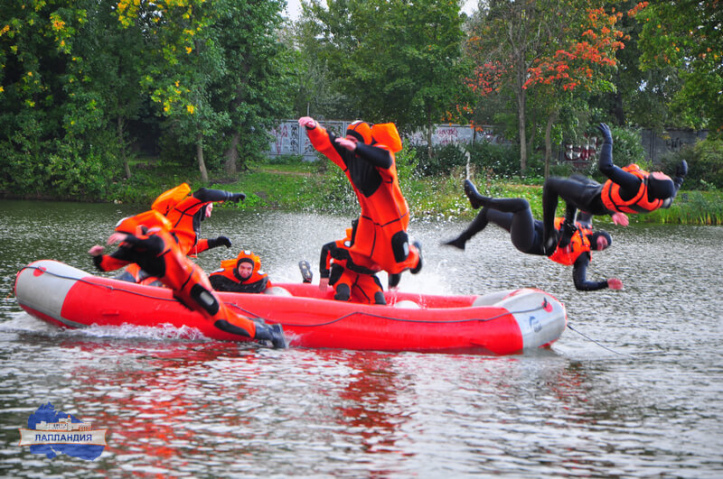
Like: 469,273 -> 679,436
442,180 -> 623,291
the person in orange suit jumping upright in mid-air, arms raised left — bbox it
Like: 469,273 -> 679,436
299,116 -> 422,275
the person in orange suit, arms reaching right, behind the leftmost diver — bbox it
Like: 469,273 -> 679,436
115,183 -> 240,286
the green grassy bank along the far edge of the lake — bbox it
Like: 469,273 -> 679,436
111,161 -> 723,225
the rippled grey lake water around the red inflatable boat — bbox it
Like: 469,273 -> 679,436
0,201 -> 723,478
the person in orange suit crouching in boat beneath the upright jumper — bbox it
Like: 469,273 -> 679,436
319,220 -> 387,305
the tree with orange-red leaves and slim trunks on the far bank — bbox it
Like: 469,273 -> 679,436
468,0 -> 622,174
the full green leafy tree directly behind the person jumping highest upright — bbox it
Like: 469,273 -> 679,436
298,0 -> 468,155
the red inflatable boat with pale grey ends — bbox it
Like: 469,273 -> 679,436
15,260 -> 567,355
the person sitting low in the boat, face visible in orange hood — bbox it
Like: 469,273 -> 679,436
208,250 -> 272,293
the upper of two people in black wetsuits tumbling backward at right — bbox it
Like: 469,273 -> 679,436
542,123 -> 688,253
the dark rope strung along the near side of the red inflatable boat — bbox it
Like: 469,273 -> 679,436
18,265 -> 548,328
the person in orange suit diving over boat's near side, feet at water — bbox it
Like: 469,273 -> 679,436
88,210 -> 286,348
